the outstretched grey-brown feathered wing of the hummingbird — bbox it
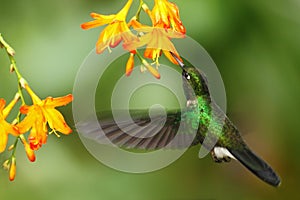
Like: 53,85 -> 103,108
76,110 -> 196,150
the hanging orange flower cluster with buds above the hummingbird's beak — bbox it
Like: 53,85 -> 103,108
81,0 -> 186,78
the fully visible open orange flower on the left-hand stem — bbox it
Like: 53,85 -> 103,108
17,80 -> 73,149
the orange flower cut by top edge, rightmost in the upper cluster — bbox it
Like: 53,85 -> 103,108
151,0 -> 186,34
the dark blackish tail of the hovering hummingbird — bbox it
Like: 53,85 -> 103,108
229,148 -> 280,187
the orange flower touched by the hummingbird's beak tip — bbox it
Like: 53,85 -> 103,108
124,19 -> 184,64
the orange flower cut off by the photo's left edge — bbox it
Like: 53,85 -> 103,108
0,95 -> 19,153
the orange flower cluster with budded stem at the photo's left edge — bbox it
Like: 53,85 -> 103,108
0,34 -> 73,181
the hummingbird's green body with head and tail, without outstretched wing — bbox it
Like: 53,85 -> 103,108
174,56 -> 281,186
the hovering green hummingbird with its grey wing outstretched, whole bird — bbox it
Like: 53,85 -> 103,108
79,54 -> 281,187
